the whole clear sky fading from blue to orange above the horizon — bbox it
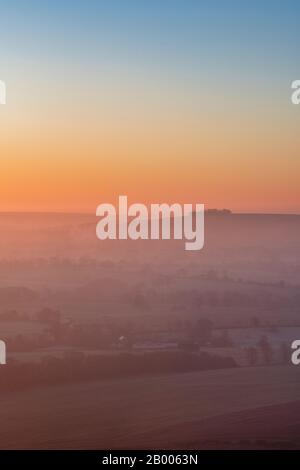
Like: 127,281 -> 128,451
0,0 -> 300,213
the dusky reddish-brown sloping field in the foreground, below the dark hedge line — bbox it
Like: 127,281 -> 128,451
0,366 -> 300,449
